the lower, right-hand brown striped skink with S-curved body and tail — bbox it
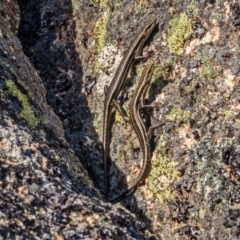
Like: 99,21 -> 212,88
111,64 -> 153,202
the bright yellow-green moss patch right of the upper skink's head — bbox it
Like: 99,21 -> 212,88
168,13 -> 193,55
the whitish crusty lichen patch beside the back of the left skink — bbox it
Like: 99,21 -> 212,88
96,45 -> 122,96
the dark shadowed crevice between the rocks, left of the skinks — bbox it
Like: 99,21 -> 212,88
18,0 -> 103,195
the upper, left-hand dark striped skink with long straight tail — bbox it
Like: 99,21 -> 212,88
103,19 -> 157,199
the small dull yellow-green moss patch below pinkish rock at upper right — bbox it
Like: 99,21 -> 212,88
199,56 -> 218,80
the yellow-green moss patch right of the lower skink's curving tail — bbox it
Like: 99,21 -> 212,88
148,146 -> 180,203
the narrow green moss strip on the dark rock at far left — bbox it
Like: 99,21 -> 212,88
6,80 -> 38,126
